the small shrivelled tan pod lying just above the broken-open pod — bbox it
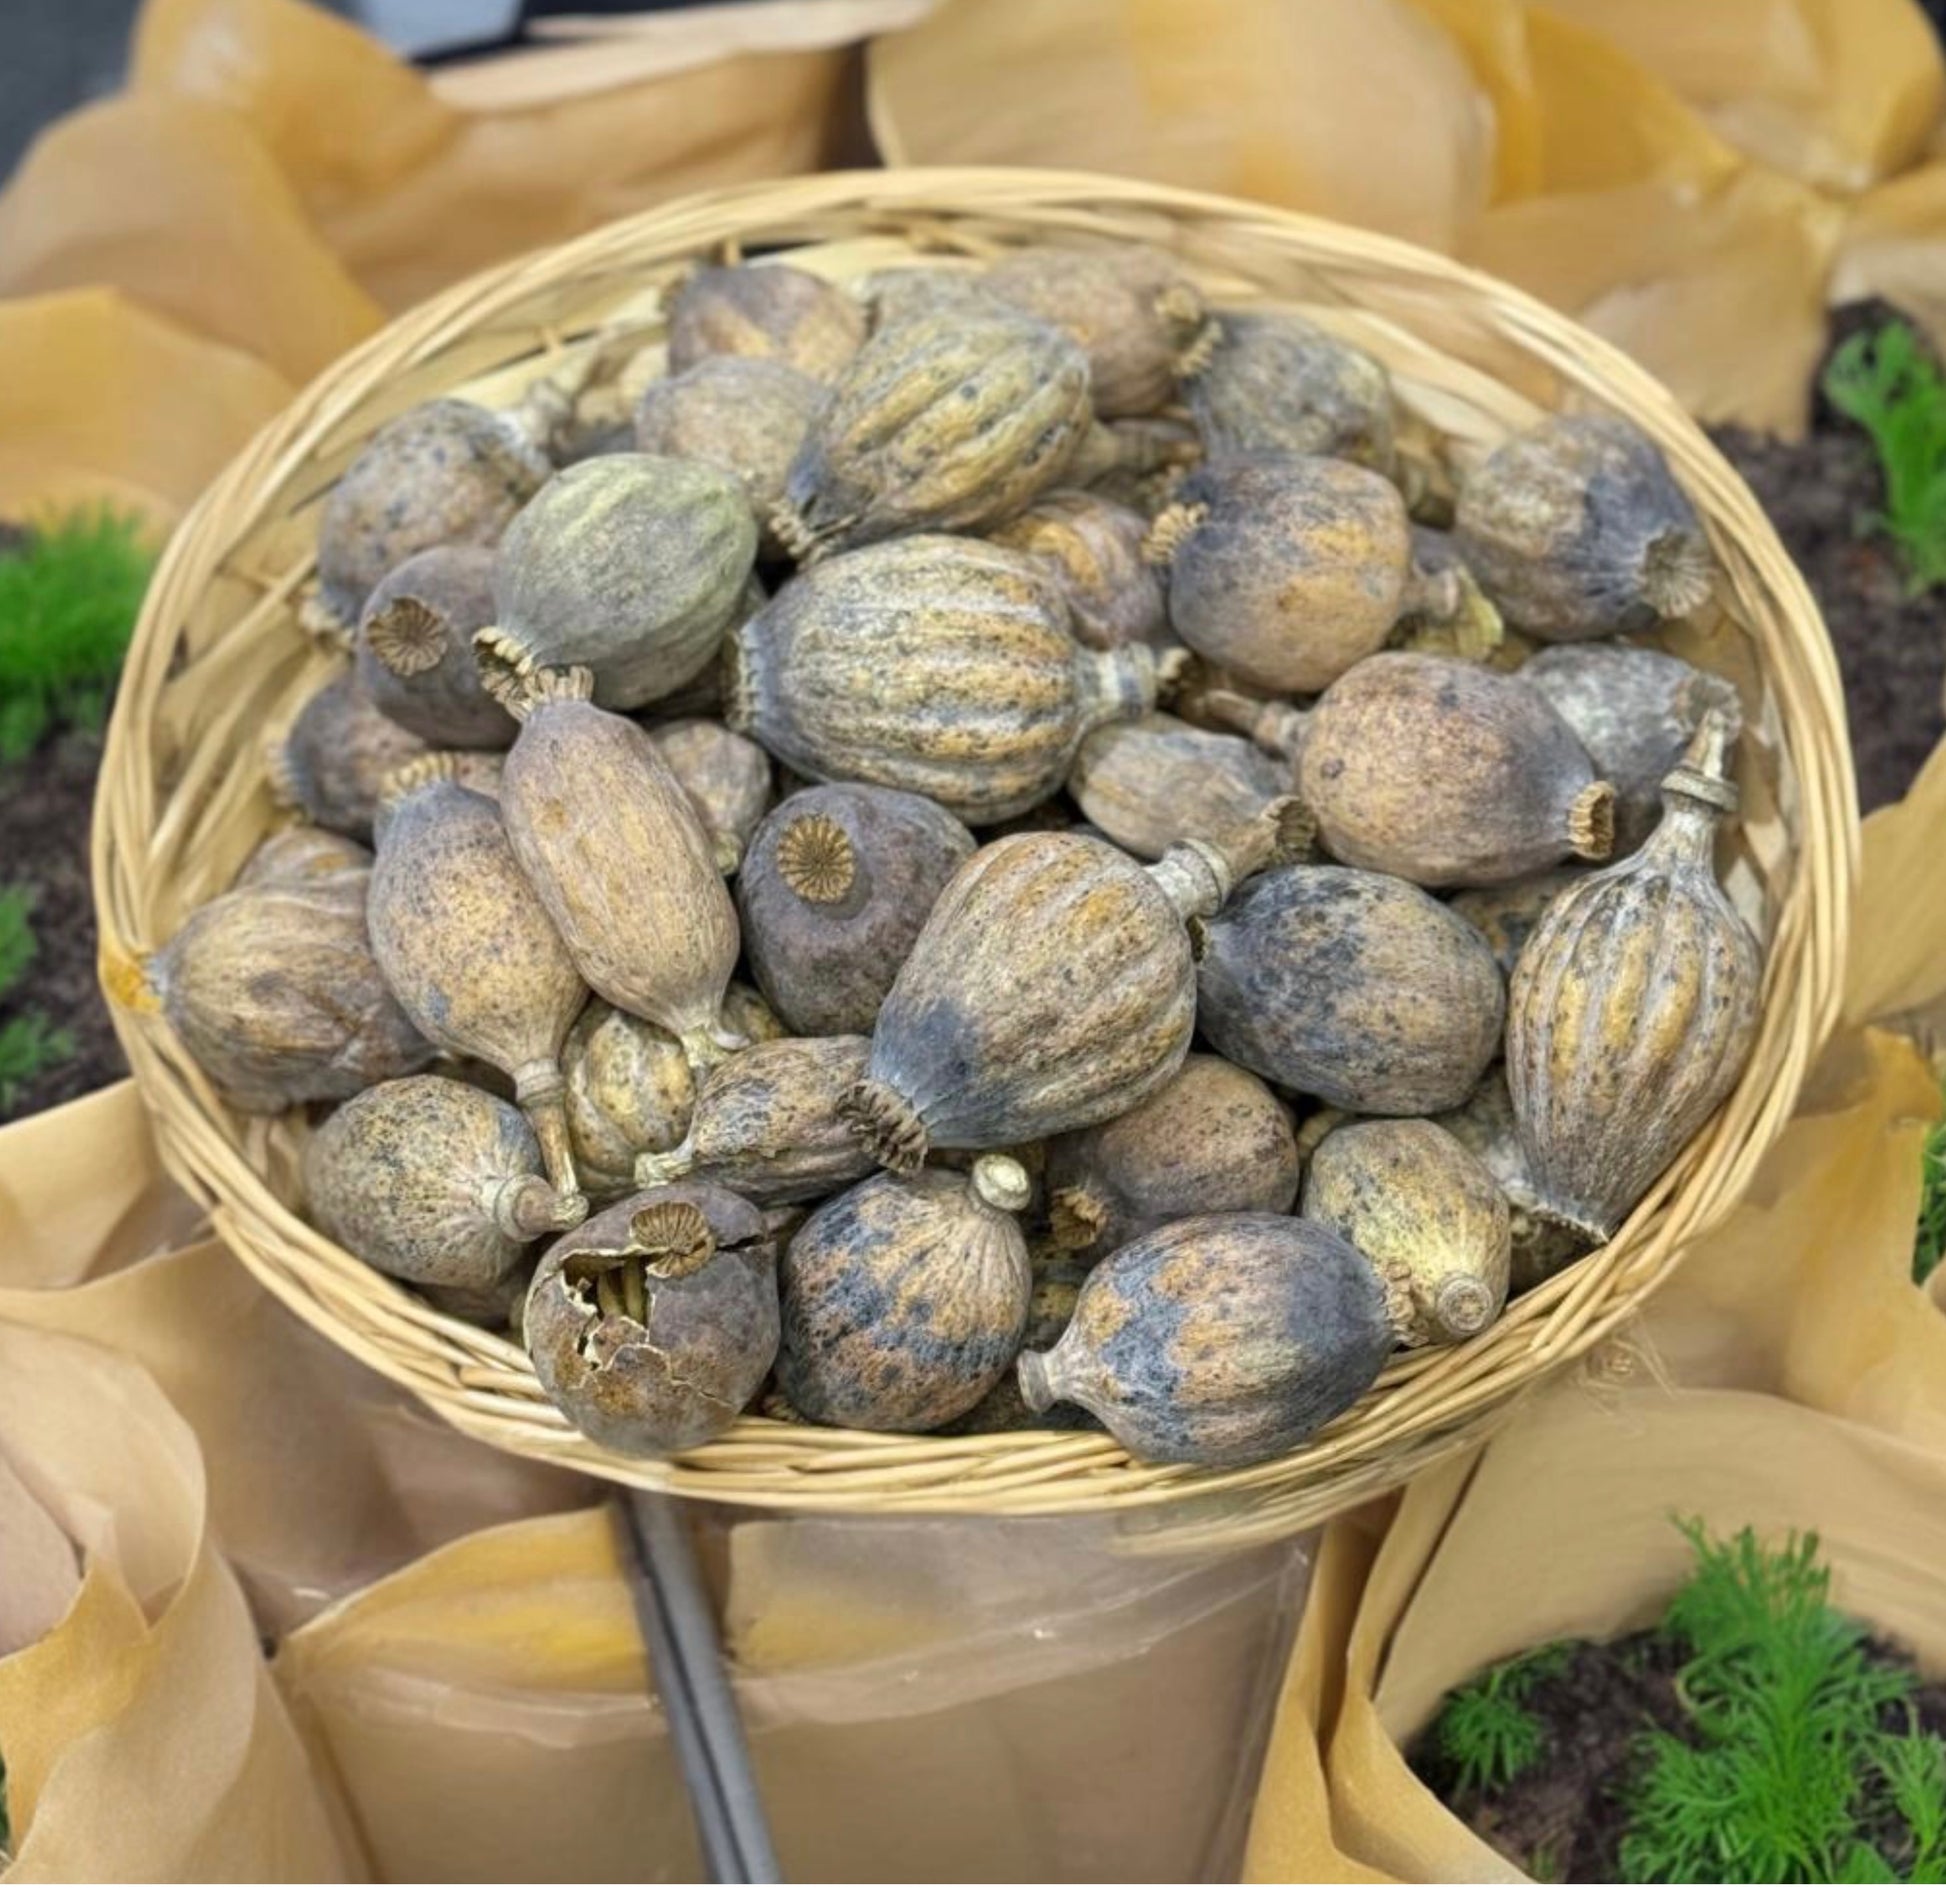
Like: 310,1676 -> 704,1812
634,1038 -> 874,1207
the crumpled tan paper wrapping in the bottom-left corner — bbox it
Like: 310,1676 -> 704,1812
0,1322 -> 360,1882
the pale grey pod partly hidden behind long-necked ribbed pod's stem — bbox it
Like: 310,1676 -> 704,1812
1520,644 -> 1742,855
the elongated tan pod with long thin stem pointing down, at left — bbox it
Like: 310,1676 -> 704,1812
370,755 -> 588,1197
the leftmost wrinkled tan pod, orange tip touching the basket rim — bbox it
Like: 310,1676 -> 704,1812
131,868 -> 432,1113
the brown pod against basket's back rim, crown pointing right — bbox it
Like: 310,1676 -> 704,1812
981,243 -> 1216,420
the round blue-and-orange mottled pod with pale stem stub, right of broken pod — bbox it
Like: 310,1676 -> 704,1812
776,1154 -> 1033,1433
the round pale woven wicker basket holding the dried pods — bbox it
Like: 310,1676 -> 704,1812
93,171 -> 1856,1536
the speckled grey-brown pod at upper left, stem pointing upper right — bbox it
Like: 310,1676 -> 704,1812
317,399 -> 553,625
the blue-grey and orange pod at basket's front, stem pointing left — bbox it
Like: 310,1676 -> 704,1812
1018,1211 -> 1397,1466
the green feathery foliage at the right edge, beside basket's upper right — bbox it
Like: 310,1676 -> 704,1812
1823,323 -> 1946,592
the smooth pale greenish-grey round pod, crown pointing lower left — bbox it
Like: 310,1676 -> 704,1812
475,454 -> 757,710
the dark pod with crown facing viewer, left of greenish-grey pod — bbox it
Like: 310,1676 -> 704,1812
352,545 -> 514,749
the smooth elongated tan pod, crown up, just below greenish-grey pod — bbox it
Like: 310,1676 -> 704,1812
500,666 -> 745,1071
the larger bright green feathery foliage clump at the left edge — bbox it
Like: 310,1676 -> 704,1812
0,508 -> 154,763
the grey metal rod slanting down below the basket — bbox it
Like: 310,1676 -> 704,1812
615,1491 -> 784,1886
